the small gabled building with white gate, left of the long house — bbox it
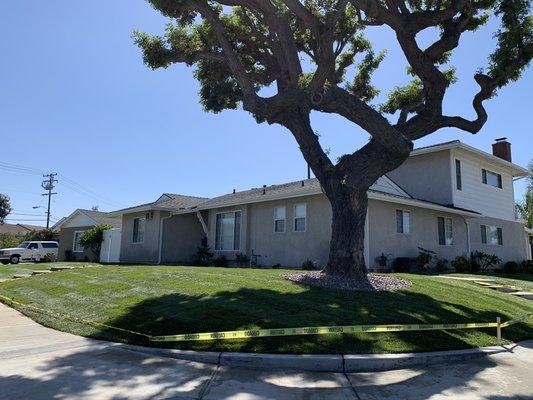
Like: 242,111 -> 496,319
53,209 -> 122,262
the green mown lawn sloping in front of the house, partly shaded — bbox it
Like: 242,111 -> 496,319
0,266 -> 533,353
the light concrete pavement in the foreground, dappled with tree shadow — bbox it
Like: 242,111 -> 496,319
0,304 -> 533,400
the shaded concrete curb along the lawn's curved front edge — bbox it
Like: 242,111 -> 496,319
119,340 -> 520,373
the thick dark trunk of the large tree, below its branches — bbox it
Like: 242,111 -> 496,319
323,187 -> 368,280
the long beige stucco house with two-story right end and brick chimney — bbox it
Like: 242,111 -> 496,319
109,140 -> 530,270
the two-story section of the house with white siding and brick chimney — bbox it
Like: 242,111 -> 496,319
388,138 -> 529,261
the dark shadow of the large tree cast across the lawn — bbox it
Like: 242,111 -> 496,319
94,287 -> 533,354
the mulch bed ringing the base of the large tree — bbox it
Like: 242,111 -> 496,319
283,271 -> 411,292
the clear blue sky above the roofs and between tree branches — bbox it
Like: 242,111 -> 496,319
0,0 -> 533,224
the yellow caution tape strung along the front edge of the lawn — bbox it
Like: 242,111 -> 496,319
0,295 -> 533,342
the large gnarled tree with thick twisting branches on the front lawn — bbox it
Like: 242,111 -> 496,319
134,0 -> 533,279
